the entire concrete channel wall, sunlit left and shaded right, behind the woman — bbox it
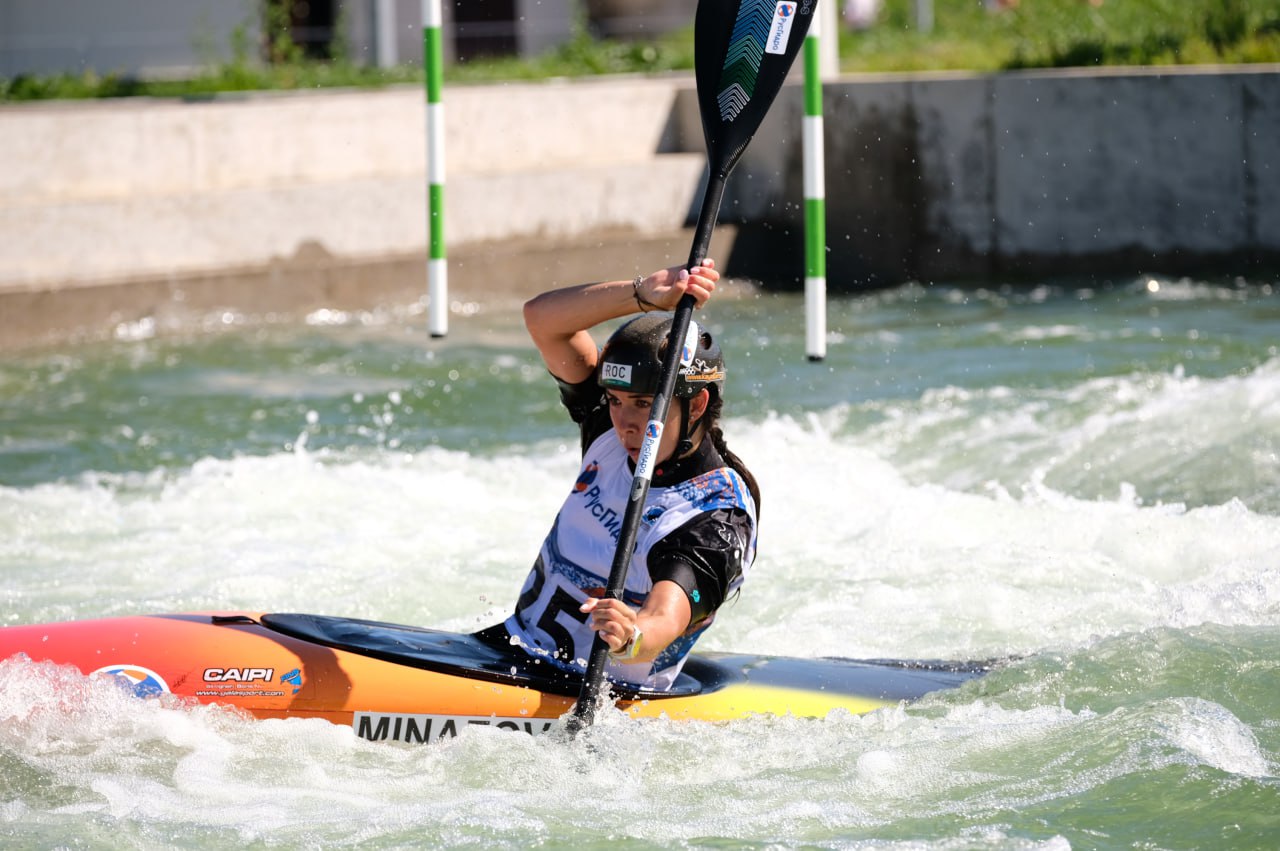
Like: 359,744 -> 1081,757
0,67 -> 1280,347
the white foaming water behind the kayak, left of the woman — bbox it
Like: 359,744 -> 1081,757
0,449 -> 575,624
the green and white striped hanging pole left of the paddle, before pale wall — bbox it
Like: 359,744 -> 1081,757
422,0 -> 449,337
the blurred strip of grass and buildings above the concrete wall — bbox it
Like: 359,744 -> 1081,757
0,0 -> 1280,92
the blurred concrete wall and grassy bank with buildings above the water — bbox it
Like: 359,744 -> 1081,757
0,0 -> 1280,348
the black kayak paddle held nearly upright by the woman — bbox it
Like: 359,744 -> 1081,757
567,0 -> 818,735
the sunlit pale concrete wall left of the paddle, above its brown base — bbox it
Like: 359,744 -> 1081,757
0,79 -> 703,295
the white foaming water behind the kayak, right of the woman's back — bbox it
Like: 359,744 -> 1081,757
709,409 -> 1280,658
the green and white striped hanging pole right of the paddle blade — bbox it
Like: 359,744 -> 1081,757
801,4 -> 827,361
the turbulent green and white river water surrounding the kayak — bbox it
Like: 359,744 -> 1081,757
0,278 -> 1280,850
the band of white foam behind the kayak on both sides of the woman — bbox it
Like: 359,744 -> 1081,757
0,396 -> 1280,659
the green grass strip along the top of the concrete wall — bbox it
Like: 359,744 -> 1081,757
0,0 -> 1280,102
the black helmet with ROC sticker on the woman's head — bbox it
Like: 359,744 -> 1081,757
596,314 -> 724,399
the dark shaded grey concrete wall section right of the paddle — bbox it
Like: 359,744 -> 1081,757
737,67 -> 1280,290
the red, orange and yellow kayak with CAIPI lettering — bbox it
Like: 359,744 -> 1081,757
0,612 -> 989,742
